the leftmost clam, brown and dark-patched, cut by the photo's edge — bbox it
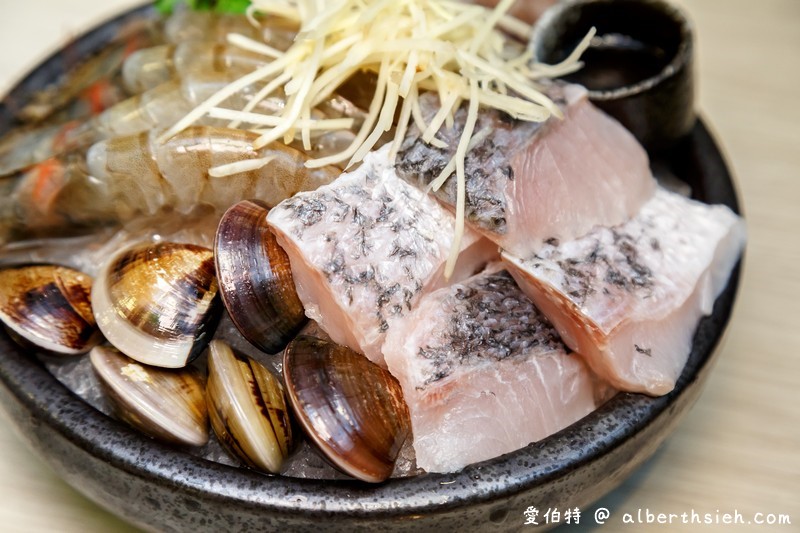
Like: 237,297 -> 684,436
0,265 -> 102,355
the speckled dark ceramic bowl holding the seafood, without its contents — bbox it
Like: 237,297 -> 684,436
0,4 -> 739,532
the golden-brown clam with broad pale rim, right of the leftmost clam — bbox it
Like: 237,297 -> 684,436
92,242 -> 222,368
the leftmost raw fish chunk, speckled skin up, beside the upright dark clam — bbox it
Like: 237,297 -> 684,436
267,144 -> 498,364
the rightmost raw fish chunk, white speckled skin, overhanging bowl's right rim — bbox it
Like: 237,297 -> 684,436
503,189 -> 745,395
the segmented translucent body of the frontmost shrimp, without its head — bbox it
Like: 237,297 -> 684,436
86,126 -> 338,214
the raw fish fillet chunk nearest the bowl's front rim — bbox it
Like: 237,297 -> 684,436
384,263 -> 613,472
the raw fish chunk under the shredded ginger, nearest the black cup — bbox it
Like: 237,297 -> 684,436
396,85 -> 656,257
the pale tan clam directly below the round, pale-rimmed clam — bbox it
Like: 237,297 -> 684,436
89,346 -> 208,446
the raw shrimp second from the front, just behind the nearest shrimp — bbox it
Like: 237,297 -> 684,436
0,72 -> 366,176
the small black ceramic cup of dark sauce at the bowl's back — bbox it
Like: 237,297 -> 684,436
531,0 -> 696,153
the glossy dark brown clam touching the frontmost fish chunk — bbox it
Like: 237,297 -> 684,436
283,335 -> 411,482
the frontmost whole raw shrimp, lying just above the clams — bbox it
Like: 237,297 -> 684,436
0,126 -> 339,239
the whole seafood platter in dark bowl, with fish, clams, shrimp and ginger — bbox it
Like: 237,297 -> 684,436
0,0 -> 746,531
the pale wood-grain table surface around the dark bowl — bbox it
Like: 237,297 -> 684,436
0,0 -> 800,533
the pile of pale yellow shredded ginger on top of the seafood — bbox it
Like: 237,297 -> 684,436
160,0 -> 593,277
